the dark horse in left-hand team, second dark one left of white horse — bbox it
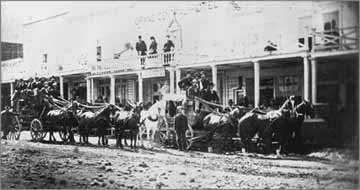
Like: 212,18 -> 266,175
77,104 -> 114,145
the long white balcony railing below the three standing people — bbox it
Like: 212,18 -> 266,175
89,52 -> 177,73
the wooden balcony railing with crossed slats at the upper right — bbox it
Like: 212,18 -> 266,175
312,27 -> 359,51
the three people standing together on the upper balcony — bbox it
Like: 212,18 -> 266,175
135,35 -> 175,66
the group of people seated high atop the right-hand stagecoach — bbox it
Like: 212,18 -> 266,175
178,71 -> 219,103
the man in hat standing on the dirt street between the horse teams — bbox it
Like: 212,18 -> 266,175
175,106 -> 188,151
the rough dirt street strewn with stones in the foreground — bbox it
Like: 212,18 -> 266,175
1,132 -> 359,189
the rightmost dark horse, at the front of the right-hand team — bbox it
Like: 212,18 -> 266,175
271,100 -> 315,153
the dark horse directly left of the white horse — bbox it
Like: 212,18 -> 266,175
113,103 -> 141,148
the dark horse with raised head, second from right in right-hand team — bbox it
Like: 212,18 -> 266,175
237,99 -> 290,153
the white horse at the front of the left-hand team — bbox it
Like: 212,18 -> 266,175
138,100 -> 166,148
